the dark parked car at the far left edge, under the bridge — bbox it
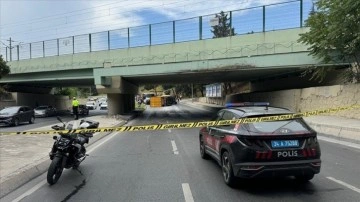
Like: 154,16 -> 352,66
0,106 -> 35,126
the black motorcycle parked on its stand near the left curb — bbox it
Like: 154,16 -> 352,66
47,117 -> 99,185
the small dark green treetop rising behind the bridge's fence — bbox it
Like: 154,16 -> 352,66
211,11 -> 235,38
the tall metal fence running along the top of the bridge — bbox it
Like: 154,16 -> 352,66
4,0 -> 312,61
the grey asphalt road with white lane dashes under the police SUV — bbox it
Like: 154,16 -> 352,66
1,104 -> 360,202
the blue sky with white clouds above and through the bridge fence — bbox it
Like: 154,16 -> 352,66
0,0 -> 311,59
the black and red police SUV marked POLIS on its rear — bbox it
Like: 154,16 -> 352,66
199,103 -> 321,186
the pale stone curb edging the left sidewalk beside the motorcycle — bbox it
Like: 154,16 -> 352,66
0,114 -> 137,199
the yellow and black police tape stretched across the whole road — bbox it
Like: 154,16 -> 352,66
0,105 -> 360,135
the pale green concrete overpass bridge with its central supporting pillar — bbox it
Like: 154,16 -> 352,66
0,28 -> 334,114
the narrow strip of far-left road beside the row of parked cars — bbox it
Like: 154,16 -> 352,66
0,108 -> 107,132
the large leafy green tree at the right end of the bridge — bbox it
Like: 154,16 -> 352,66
299,0 -> 360,82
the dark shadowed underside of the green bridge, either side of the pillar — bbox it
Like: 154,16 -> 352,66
1,67 -> 302,87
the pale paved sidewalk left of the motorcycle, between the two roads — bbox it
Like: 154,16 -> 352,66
0,115 -> 133,198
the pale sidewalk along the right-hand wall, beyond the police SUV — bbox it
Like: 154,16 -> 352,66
182,100 -> 360,144
